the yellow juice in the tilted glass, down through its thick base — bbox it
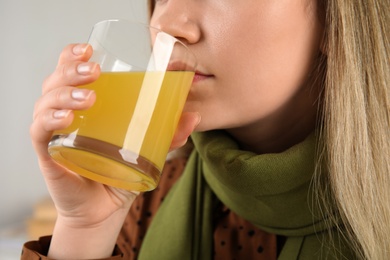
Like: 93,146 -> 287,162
49,71 -> 194,191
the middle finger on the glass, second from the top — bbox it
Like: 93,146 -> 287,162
42,61 -> 100,94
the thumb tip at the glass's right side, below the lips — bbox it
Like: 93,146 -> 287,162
170,112 -> 201,150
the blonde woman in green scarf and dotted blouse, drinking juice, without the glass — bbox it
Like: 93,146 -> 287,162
23,0 -> 390,259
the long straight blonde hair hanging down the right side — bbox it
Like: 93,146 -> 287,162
321,0 -> 390,260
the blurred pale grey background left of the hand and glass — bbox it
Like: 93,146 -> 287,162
0,0 -> 146,260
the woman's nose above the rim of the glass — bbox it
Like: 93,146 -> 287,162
150,0 -> 201,44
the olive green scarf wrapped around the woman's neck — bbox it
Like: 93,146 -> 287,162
139,131 -> 354,260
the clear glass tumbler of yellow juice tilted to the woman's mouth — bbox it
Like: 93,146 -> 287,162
48,20 -> 196,191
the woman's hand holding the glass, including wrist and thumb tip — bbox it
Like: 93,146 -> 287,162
30,44 -> 200,258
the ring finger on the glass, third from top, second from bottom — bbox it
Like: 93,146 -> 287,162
33,87 -> 96,120
